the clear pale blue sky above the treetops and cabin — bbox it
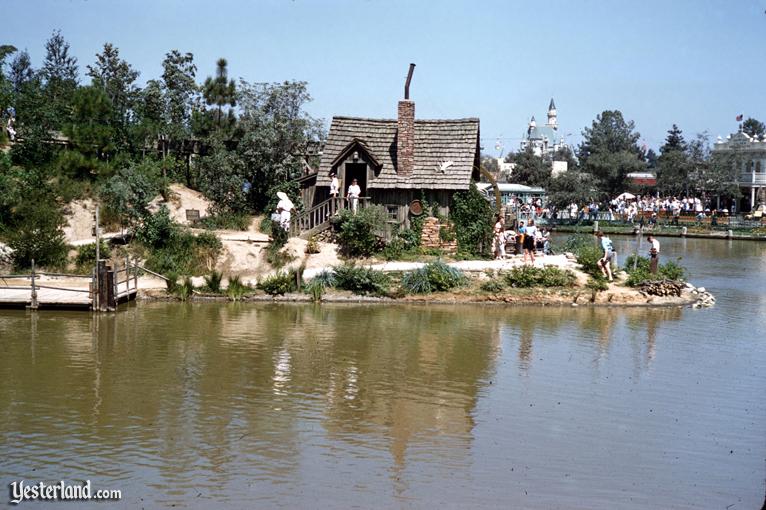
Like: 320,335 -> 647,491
0,0 -> 766,154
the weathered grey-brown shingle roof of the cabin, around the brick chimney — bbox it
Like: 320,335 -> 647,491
317,117 -> 479,189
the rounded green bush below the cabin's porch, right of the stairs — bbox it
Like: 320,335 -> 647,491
335,206 -> 388,257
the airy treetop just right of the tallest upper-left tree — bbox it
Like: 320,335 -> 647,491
87,43 -> 139,129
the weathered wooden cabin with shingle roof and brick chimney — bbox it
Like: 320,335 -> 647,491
307,93 -> 480,225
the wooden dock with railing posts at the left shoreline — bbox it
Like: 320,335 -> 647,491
0,259 -> 142,311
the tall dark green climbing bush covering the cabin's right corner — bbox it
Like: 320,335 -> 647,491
450,182 -> 494,257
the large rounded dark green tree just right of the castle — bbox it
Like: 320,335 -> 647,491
578,110 -> 646,194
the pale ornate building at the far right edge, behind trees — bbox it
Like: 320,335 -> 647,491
713,127 -> 766,211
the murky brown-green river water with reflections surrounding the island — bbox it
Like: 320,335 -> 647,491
0,238 -> 766,510
